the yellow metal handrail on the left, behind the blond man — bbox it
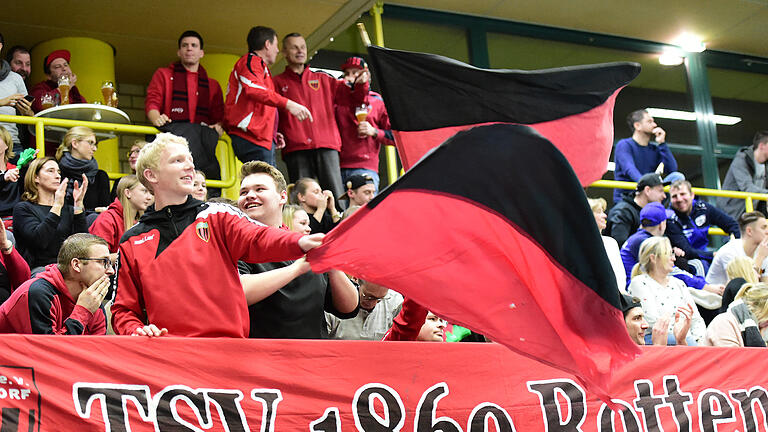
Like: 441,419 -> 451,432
0,114 -> 236,189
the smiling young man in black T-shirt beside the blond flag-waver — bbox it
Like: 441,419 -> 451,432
237,161 -> 358,339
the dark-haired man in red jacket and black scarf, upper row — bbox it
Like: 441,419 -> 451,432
144,30 -> 224,186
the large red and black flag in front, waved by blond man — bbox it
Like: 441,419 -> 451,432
308,124 -> 639,394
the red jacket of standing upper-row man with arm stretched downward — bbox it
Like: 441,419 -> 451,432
275,66 -> 368,153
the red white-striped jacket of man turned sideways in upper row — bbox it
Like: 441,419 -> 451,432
224,53 -> 288,149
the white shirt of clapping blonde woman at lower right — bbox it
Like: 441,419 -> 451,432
627,274 -> 707,344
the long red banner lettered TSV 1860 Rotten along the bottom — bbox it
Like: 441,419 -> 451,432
0,335 -> 768,432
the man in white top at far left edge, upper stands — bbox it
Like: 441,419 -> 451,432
0,34 -> 34,159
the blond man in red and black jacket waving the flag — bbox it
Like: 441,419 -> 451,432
112,133 -> 323,337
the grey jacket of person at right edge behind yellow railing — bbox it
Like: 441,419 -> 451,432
717,146 -> 768,220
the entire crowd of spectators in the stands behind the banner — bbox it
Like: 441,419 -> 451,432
0,26 -> 768,352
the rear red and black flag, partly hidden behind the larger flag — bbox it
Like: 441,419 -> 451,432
368,46 -> 640,186
